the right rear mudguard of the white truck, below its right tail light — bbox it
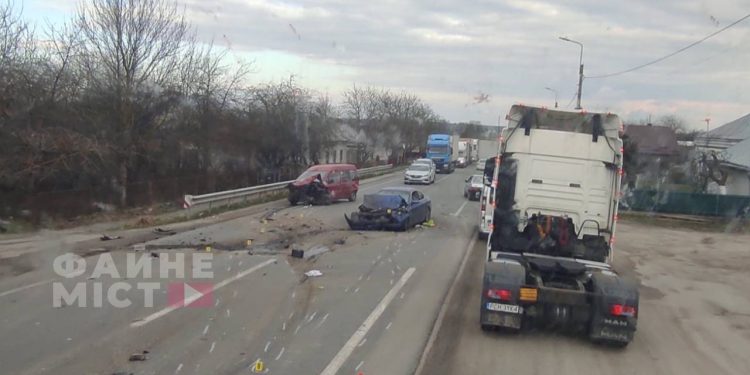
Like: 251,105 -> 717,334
589,272 -> 639,346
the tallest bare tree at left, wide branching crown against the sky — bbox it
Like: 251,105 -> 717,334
76,0 -> 192,206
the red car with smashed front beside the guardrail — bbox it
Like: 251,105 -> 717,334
287,164 -> 359,205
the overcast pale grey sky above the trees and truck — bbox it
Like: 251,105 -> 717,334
24,0 -> 750,129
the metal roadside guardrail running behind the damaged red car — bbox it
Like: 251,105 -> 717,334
183,164 -> 393,209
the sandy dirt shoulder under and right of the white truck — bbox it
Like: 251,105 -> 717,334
420,223 -> 750,375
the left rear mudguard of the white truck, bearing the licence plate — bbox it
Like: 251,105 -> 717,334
479,260 -> 526,331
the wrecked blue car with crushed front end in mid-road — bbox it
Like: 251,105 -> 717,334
344,187 -> 432,230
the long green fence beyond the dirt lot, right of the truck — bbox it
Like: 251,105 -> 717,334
622,190 -> 750,217
